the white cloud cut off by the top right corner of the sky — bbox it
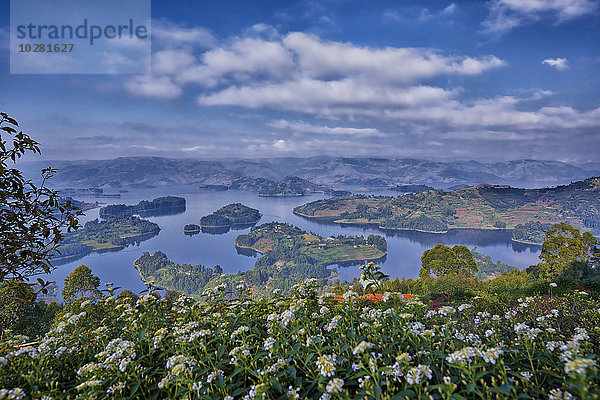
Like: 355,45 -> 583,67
483,0 -> 598,34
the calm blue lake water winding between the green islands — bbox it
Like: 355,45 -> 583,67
49,187 -> 541,292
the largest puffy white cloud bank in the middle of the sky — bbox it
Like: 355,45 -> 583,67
129,22 -> 505,98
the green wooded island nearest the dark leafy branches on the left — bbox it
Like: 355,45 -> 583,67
52,216 -> 160,264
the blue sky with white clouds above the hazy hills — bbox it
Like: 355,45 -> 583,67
0,0 -> 600,164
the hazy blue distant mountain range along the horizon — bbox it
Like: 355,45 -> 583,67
21,156 -> 600,188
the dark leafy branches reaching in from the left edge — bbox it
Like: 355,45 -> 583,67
0,113 -> 82,290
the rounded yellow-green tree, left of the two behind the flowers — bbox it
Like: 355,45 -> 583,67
419,244 -> 479,278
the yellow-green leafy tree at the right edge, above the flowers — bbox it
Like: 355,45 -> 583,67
538,222 -> 598,278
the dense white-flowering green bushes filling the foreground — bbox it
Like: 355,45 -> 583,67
0,281 -> 600,399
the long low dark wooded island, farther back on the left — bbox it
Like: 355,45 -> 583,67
100,196 -> 185,218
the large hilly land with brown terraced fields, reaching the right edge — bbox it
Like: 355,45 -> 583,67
294,177 -> 600,244
